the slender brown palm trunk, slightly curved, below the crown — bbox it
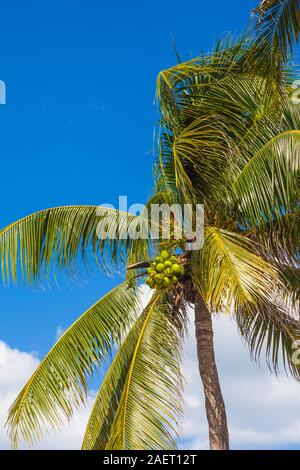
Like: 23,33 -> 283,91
195,293 -> 229,450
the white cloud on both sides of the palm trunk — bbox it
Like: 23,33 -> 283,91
181,316 -> 300,449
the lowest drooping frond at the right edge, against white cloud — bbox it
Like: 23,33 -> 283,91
236,302 -> 300,380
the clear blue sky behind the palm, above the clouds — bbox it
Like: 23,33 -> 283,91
4,0 -> 300,447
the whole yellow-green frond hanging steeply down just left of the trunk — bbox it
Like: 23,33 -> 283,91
84,294 -> 185,450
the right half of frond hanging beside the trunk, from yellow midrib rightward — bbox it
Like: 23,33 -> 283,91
106,294 -> 184,450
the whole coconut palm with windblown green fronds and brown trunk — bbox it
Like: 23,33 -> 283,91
0,2 -> 300,450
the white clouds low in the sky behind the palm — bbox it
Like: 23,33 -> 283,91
0,306 -> 300,449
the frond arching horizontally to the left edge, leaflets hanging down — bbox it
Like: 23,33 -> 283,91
0,206 -> 148,283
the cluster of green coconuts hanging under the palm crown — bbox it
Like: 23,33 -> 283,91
146,250 -> 184,289
